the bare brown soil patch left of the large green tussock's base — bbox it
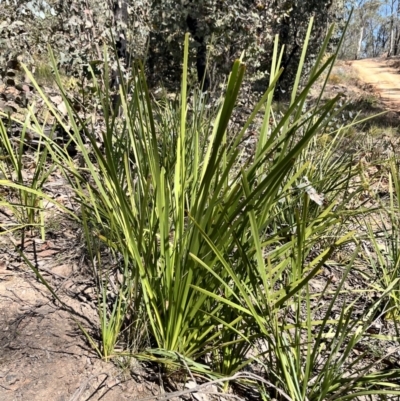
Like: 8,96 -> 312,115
0,231 -> 159,401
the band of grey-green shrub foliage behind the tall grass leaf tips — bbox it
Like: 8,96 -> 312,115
0,0 -> 342,93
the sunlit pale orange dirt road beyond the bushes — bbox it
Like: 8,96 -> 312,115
352,58 -> 400,112
